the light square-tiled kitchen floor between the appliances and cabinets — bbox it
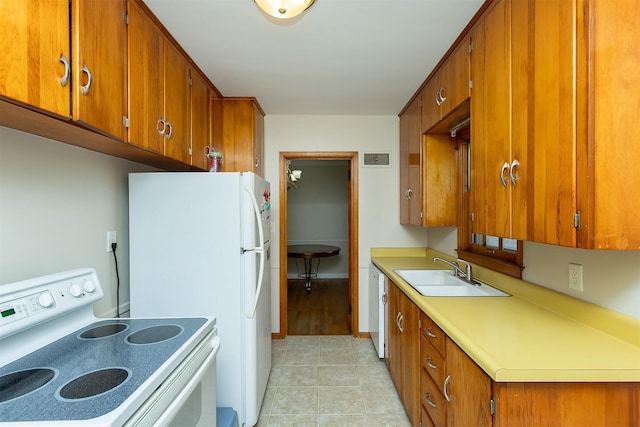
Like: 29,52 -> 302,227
258,335 -> 411,427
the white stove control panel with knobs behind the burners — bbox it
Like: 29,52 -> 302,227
0,269 -> 104,338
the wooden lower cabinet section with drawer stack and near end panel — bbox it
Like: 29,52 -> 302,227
420,313 -> 640,427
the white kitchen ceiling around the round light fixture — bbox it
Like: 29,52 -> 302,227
144,0 -> 483,115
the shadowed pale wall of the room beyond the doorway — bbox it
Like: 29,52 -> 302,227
287,160 -> 349,279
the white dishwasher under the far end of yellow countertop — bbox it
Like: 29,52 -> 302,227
369,263 -> 389,359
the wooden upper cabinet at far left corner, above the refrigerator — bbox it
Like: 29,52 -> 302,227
222,98 -> 264,176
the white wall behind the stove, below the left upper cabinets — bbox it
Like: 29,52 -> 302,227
0,127 -> 157,316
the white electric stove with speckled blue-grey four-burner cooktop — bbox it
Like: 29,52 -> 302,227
0,268 -> 220,427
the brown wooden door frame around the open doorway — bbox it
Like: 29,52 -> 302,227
274,151 -> 360,338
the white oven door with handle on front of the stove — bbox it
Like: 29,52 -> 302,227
124,330 -> 220,427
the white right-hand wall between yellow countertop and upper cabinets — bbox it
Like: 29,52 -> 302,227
429,228 -> 640,319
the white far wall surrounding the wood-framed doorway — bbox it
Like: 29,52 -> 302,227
265,115 -> 427,332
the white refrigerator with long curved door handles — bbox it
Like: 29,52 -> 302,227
129,172 -> 271,426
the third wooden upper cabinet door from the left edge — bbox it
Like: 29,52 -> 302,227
128,1 -> 164,154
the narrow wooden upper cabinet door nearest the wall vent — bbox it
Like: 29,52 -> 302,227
400,96 -> 422,225
